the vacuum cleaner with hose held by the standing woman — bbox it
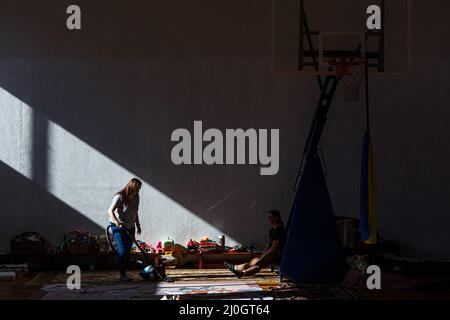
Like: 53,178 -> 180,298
106,225 -> 173,282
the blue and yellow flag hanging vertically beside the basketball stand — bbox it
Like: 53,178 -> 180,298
360,132 -> 378,244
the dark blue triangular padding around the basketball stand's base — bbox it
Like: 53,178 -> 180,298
280,155 -> 347,283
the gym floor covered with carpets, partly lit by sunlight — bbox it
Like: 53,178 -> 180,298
0,269 -> 448,300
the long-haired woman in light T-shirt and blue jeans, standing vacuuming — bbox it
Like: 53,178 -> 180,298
108,178 -> 142,281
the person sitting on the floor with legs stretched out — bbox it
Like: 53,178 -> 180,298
224,210 -> 286,278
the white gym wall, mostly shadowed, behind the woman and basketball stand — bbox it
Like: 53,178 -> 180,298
0,0 -> 450,258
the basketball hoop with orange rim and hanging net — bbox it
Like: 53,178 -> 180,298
328,58 -> 366,101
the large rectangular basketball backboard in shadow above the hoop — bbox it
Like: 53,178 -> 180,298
272,0 -> 409,74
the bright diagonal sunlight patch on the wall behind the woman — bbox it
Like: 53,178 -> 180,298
0,88 -> 237,244
